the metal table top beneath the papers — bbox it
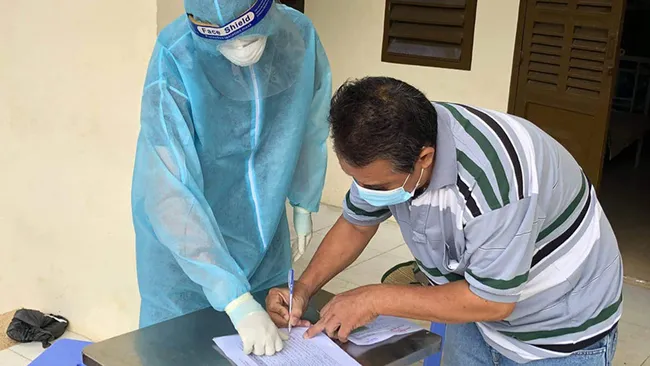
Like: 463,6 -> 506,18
83,291 -> 441,366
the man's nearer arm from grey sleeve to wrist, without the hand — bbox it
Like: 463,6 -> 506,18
377,196 -> 543,323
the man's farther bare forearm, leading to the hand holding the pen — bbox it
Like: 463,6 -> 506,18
298,216 -> 379,297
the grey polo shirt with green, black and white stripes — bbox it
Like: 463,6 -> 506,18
343,103 -> 623,363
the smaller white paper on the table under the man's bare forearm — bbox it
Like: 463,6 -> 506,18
348,315 -> 423,346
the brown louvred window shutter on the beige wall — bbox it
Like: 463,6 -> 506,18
382,0 -> 477,70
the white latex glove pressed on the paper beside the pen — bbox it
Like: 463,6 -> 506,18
226,293 -> 289,356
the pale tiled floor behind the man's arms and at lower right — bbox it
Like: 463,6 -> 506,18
289,205 -> 650,366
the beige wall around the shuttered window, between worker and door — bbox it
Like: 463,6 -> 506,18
305,0 -> 519,206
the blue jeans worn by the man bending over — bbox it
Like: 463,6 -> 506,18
442,323 -> 618,366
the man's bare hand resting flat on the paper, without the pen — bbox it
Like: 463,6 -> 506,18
305,285 -> 381,342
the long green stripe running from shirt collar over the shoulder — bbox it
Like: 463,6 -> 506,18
440,103 -> 510,206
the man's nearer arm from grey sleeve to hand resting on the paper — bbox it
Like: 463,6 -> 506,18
307,196 -> 543,341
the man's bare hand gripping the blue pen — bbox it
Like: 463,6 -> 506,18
266,281 -> 311,328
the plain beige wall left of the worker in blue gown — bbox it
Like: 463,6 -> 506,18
0,0 -> 156,339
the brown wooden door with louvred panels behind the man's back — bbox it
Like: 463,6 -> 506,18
510,0 -> 624,184
